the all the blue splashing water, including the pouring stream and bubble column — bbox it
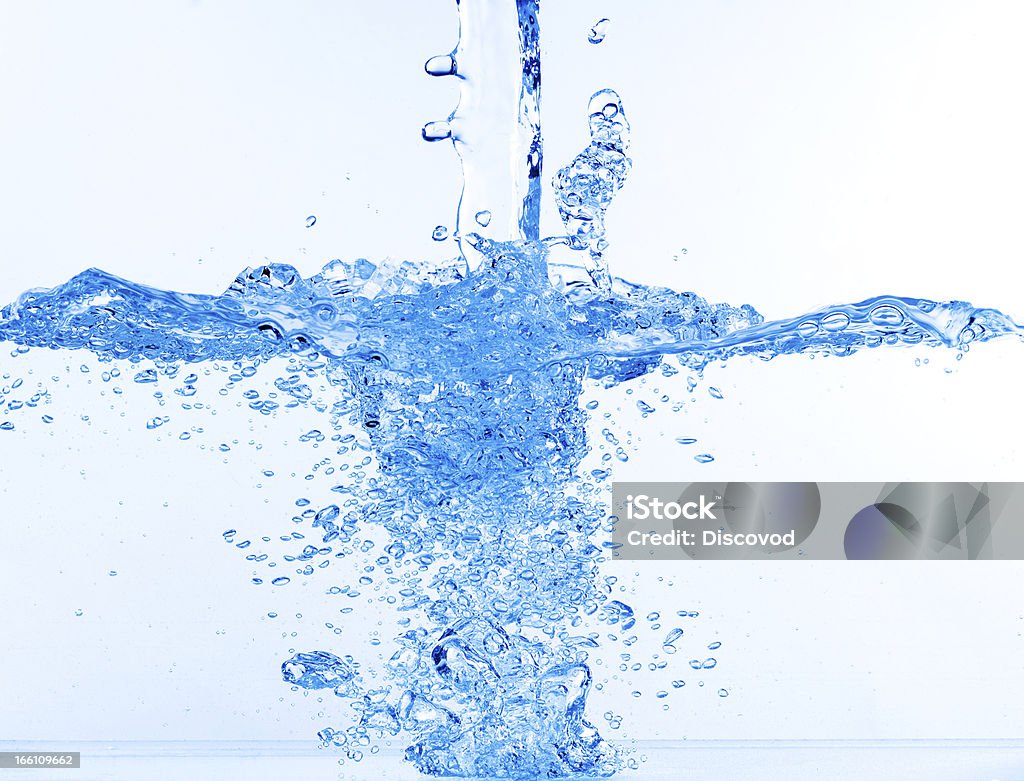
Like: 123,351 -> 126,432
0,0 -> 1024,777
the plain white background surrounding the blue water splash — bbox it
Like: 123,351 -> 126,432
0,0 -> 1024,739
